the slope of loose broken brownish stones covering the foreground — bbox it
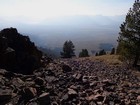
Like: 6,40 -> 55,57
0,59 -> 140,105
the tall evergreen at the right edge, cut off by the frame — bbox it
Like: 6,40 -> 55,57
117,0 -> 140,66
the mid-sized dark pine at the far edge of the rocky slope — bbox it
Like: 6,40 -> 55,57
60,40 -> 75,58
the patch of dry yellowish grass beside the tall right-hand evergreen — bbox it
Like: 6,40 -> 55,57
90,55 -> 122,65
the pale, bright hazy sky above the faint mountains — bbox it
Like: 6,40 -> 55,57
0,0 -> 134,22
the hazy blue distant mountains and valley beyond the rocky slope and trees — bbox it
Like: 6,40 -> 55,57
0,15 -> 125,54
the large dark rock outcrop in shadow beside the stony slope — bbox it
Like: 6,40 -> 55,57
0,28 -> 42,74
